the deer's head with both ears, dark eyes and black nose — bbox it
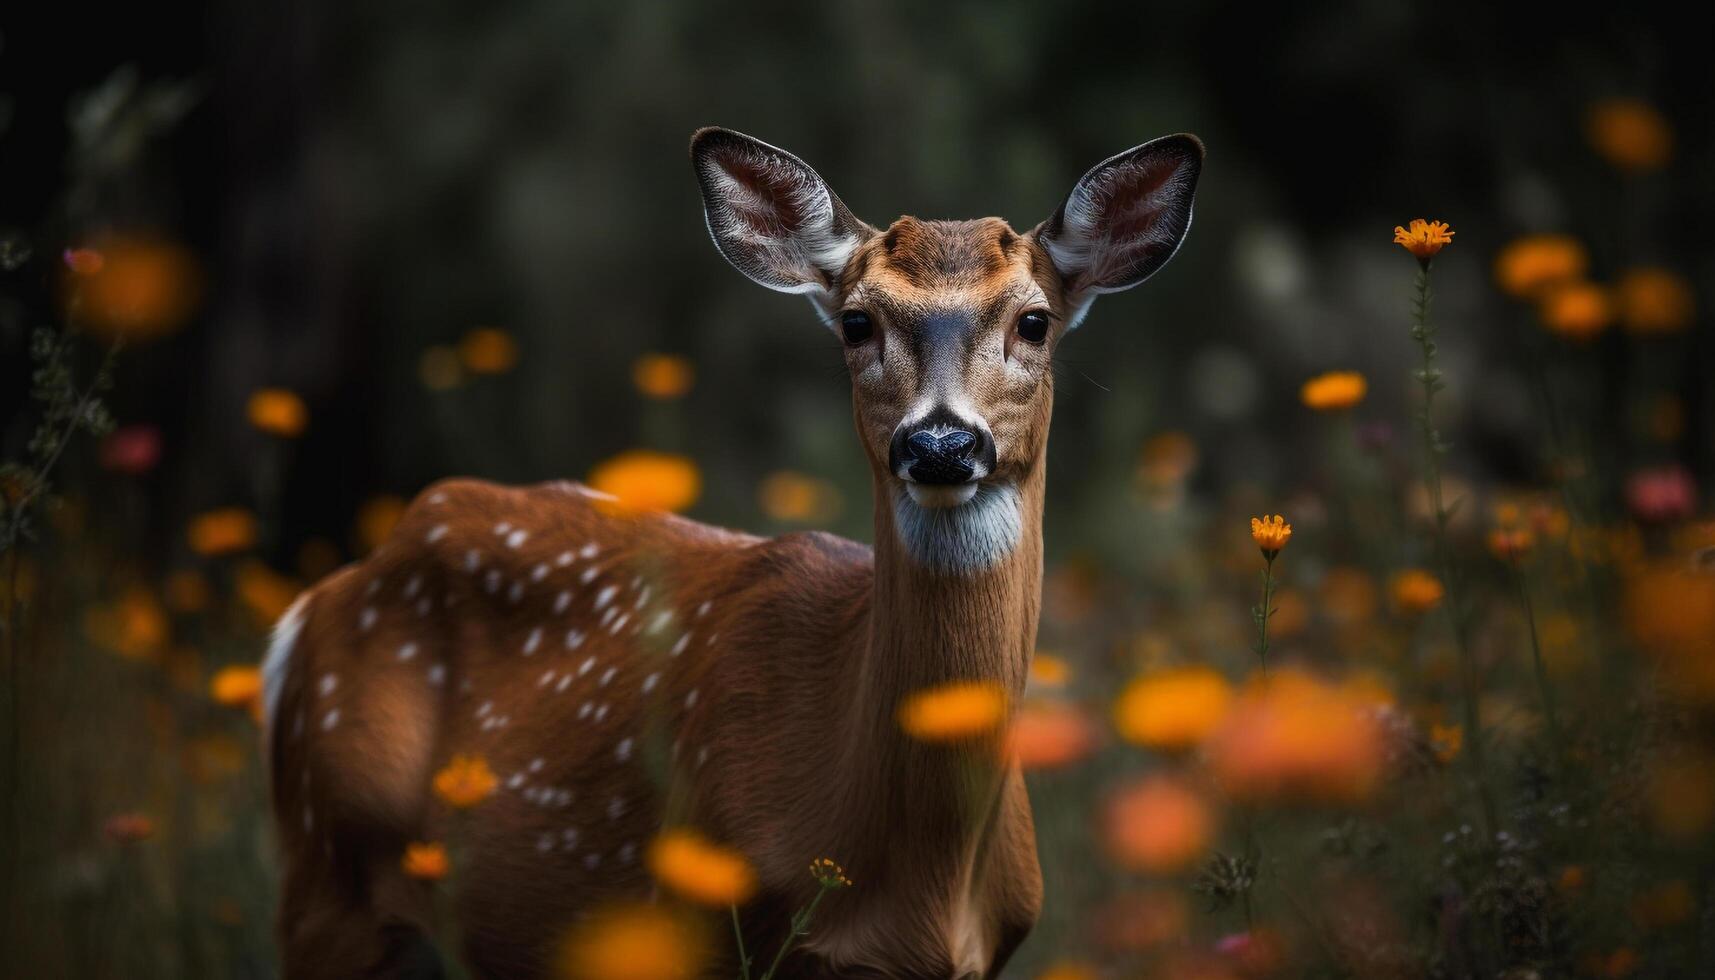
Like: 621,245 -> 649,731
691,129 -> 1202,576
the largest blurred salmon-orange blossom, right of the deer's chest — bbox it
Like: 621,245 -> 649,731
1209,669 -> 1382,803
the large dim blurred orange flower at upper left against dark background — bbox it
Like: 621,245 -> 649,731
70,237 -> 202,342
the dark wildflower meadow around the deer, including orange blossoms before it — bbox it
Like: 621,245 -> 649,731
0,0 -> 1715,980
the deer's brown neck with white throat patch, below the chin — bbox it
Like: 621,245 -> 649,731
823,465 -> 1044,870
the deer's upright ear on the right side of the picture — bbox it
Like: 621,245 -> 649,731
1036,134 -> 1202,320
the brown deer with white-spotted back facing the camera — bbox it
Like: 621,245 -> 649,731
262,129 -> 1204,980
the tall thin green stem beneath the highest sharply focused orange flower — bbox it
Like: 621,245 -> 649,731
1411,259 -> 1501,838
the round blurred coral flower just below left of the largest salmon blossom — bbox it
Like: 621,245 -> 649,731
1103,776 -> 1216,875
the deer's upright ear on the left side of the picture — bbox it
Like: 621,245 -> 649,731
691,127 -> 875,300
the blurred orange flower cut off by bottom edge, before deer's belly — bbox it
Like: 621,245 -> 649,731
557,904 -> 710,980
